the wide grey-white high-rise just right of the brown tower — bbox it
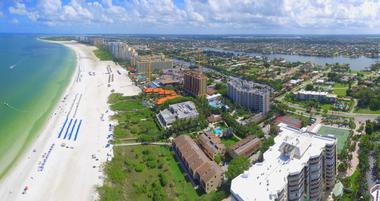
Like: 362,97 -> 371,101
227,78 -> 270,114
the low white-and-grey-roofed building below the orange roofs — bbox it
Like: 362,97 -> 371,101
156,101 -> 199,128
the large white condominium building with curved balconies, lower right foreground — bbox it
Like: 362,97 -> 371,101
231,124 -> 336,201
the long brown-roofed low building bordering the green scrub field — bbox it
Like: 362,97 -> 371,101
173,135 -> 223,193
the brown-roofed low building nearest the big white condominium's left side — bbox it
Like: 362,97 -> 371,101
228,135 -> 261,158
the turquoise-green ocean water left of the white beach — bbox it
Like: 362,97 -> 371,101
0,35 -> 76,178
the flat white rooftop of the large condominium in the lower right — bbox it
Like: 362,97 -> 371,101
231,124 -> 336,201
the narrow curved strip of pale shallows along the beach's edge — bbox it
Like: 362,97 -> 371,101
0,38 -> 77,178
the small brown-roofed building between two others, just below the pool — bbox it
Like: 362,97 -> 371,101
198,132 -> 226,160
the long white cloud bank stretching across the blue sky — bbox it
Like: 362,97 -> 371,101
5,0 -> 380,31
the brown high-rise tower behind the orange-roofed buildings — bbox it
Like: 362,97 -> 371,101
183,70 -> 207,97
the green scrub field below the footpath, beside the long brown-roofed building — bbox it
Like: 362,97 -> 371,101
98,146 -> 206,201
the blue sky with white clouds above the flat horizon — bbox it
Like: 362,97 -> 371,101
0,0 -> 380,34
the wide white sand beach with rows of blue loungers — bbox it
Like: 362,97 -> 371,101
0,42 -> 140,201
